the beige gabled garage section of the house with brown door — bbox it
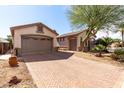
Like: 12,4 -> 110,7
10,22 -> 58,56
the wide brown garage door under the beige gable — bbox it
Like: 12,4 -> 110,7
22,37 -> 52,55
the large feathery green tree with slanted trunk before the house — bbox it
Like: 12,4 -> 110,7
68,5 -> 124,49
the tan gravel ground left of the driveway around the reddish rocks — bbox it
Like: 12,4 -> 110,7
0,61 -> 36,88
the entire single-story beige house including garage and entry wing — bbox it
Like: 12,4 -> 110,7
10,22 -> 95,56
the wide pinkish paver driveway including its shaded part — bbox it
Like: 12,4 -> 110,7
24,53 -> 123,88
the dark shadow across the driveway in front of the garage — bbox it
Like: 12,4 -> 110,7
22,52 -> 74,62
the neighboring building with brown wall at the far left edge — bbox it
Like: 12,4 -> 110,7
0,38 -> 9,54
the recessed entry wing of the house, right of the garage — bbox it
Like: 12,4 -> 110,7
57,30 -> 94,51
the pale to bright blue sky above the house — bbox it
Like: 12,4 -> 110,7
0,5 -> 120,38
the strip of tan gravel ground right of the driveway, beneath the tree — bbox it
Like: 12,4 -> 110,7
75,52 -> 124,66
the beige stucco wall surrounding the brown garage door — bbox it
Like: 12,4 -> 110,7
13,26 -> 57,48
